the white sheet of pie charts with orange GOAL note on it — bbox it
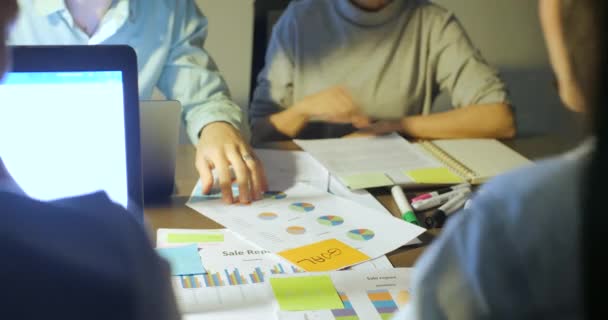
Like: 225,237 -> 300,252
187,184 -> 425,271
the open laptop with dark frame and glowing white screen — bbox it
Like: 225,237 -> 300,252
0,46 -> 143,219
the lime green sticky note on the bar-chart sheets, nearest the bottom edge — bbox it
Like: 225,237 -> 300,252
270,276 -> 344,311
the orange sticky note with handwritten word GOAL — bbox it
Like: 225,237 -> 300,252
279,239 -> 369,272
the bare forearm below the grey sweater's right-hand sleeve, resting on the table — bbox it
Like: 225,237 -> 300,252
401,104 -> 516,139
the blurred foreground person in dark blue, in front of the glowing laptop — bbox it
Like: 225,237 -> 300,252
0,0 -> 180,320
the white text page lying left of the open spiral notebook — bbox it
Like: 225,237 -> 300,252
294,134 -> 444,190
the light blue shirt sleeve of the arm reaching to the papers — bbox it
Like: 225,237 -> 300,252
158,0 -> 249,144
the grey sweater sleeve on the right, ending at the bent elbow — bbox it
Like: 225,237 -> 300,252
431,12 -> 509,107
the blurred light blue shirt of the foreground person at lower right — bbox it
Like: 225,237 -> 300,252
395,145 -> 589,320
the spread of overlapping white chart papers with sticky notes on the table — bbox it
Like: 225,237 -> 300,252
157,149 -> 425,320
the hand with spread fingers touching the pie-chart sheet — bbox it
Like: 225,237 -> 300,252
196,122 -> 267,203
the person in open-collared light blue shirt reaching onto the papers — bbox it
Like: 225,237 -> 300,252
9,0 -> 266,203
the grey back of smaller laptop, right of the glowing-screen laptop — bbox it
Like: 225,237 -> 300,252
140,100 -> 182,202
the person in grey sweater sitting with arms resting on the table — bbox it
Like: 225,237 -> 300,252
250,0 -> 515,143
